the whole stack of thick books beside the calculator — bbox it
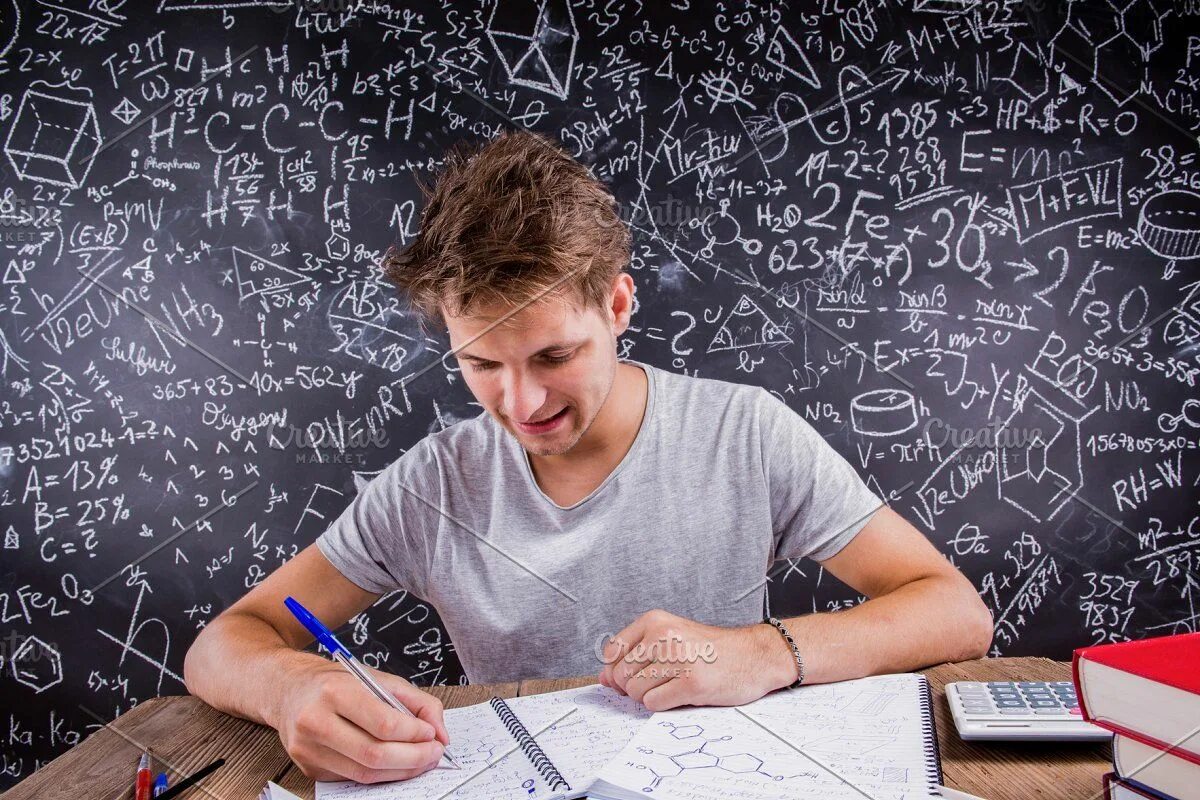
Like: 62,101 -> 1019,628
1072,633 -> 1200,800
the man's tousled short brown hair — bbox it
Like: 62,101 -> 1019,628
382,131 -> 630,329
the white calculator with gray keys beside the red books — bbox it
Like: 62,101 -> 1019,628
946,680 -> 1112,741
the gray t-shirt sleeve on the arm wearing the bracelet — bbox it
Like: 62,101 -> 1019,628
758,389 -> 882,561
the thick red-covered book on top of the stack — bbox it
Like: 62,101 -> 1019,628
1072,633 -> 1200,765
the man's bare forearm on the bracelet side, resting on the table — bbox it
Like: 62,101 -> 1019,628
767,577 -> 991,685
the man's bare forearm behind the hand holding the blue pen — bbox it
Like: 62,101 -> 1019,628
184,614 -> 328,727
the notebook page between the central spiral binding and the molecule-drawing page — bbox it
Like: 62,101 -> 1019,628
505,685 -> 652,794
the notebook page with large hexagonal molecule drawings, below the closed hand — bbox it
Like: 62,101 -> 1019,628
595,674 -> 934,800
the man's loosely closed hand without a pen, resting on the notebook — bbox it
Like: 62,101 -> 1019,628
600,610 -> 796,711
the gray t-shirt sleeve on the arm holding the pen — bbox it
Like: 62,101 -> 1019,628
317,444 -> 440,597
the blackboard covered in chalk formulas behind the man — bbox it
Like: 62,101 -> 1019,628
0,0 -> 1200,784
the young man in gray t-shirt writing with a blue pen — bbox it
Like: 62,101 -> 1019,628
184,132 -> 992,782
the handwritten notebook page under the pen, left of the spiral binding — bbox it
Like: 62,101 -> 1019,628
317,700 -> 548,800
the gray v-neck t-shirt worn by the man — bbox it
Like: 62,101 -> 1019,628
317,359 -> 881,682
